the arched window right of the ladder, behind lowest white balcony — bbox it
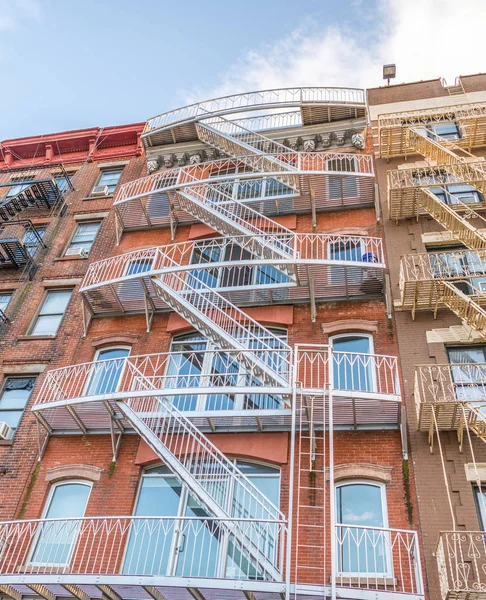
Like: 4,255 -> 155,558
336,481 -> 392,577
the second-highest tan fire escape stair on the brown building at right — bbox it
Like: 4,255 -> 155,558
418,187 -> 486,250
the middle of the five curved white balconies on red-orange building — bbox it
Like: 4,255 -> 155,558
80,232 -> 385,316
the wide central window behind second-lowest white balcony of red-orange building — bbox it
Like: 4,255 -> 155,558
166,329 -> 287,411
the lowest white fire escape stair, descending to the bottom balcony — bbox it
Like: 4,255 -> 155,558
118,375 -> 286,581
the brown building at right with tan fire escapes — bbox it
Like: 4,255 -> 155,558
368,75 -> 486,598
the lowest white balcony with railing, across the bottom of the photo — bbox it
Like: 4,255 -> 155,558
0,516 -> 423,600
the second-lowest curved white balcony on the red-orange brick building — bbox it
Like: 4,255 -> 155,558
32,346 -> 401,434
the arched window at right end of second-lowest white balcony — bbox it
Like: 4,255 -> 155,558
330,334 -> 376,392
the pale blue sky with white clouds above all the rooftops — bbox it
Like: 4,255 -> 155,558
0,0 -> 486,140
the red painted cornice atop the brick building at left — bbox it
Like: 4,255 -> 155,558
0,123 -> 145,168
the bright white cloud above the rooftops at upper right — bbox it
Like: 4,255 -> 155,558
186,0 -> 486,102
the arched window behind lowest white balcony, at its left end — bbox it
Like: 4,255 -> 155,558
29,481 -> 91,565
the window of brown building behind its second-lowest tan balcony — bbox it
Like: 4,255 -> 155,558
447,345 -> 486,410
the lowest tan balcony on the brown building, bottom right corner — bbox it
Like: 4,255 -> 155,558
436,531 -> 486,600
